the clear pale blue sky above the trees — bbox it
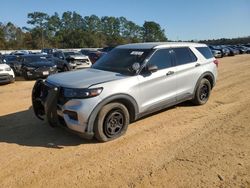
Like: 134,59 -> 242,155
0,0 -> 250,40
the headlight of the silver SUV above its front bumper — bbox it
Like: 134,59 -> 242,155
63,88 -> 103,98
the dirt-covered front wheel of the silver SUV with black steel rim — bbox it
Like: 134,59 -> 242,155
94,103 -> 129,142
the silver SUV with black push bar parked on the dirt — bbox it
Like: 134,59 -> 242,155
32,43 -> 218,142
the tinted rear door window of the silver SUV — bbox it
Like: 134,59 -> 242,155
173,47 -> 197,65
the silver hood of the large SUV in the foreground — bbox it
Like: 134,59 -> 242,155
47,68 -> 127,88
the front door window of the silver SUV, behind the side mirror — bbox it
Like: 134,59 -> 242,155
148,49 -> 172,70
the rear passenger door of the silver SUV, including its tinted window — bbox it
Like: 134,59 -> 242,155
173,47 -> 202,100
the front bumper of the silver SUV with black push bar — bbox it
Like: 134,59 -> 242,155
32,80 -> 94,139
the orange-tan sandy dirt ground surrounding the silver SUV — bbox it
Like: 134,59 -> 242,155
0,55 -> 250,187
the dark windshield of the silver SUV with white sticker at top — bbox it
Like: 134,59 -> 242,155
92,48 -> 152,75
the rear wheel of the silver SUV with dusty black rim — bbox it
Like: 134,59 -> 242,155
192,78 -> 211,105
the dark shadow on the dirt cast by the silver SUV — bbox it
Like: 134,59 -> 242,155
0,108 -> 98,149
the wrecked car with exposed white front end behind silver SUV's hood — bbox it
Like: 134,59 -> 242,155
51,51 -> 92,71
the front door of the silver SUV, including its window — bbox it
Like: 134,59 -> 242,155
138,49 -> 176,112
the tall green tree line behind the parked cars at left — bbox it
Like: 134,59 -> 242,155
0,11 -> 167,50
